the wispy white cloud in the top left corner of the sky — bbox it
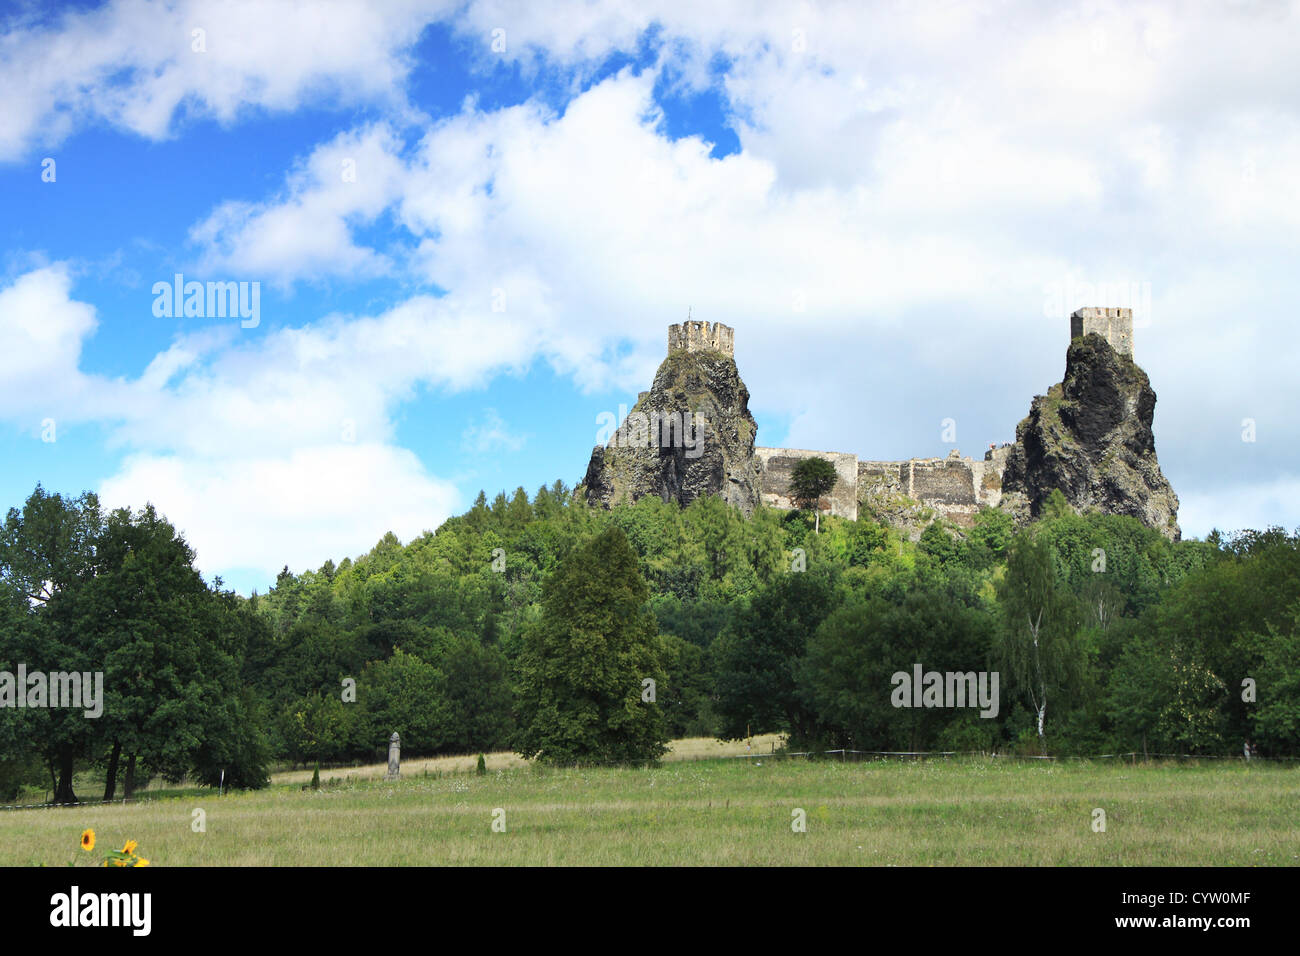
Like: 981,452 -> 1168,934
0,0 -> 454,160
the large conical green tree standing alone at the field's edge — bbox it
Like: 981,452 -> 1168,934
515,528 -> 668,763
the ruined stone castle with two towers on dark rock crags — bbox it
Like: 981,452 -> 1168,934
582,307 -> 1179,540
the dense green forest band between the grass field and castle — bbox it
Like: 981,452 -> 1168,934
0,483 -> 1300,801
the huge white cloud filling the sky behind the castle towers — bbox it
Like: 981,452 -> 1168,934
180,4 -> 1300,530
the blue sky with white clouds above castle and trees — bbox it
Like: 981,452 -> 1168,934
0,0 -> 1300,593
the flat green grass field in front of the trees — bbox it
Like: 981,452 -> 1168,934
0,757 -> 1300,866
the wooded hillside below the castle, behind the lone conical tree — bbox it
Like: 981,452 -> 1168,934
250,483 -> 1300,760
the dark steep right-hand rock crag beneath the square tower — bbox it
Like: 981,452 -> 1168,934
1001,333 -> 1182,541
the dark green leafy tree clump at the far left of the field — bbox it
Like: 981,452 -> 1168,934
0,486 -> 264,803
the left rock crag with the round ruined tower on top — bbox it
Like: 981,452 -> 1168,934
582,321 -> 762,515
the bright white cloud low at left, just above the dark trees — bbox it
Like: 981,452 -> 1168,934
0,264 -> 522,578
